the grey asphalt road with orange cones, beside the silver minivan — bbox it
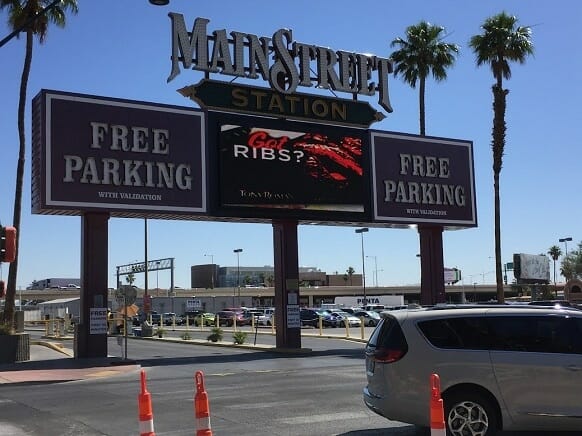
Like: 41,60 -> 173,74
0,330 -> 574,436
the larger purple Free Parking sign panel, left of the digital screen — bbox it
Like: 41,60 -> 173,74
32,90 -> 206,219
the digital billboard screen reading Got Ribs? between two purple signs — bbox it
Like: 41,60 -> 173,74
209,110 -> 367,214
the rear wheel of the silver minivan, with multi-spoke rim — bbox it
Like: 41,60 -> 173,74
444,391 -> 498,436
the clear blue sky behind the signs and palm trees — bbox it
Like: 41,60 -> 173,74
0,0 -> 582,288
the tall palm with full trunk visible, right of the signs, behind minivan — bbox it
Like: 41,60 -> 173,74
469,12 -> 534,303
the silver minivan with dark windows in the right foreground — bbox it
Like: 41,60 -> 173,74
363,305 -> 582,436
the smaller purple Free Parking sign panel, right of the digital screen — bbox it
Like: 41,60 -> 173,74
370,131 -> 477,228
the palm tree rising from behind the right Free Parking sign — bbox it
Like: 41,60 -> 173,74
390,21 -> 459,136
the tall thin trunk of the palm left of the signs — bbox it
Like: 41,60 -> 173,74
4,30 -> 34,325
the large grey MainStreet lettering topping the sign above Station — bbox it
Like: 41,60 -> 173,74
167,12 -> 392,112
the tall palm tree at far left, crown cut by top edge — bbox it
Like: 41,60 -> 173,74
0,0 -> 78,325
